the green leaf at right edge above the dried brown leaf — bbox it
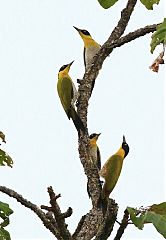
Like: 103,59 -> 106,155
150,18 -> 166,53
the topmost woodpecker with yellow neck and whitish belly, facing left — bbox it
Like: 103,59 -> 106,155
73,26 -> 101,93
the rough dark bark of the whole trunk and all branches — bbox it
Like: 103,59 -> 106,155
0,0 -> 160,240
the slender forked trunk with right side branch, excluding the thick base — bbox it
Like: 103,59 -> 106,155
78,0 -> 158,211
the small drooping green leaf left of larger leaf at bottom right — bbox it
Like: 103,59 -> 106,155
127,207 -> 145,230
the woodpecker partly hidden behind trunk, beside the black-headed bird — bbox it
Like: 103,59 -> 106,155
87,133 -> 101,198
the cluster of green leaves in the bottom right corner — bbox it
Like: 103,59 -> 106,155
127,202 -> 166,238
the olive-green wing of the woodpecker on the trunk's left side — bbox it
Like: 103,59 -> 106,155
57,78 -> 73,119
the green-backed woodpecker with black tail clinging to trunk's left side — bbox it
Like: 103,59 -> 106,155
57,61 -> 85,133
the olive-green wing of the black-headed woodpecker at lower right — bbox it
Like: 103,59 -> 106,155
104,155 -> 123,195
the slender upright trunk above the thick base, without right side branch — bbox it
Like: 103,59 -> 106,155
77,0 -> 137,210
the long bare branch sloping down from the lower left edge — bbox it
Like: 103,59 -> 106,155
0,186 -> 63,240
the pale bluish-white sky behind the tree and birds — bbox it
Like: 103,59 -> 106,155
0,0 -> 165,240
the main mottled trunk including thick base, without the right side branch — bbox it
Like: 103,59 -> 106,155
73,0 -> 140,240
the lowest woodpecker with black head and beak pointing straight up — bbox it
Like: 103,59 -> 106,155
99,136 -> 129,199
